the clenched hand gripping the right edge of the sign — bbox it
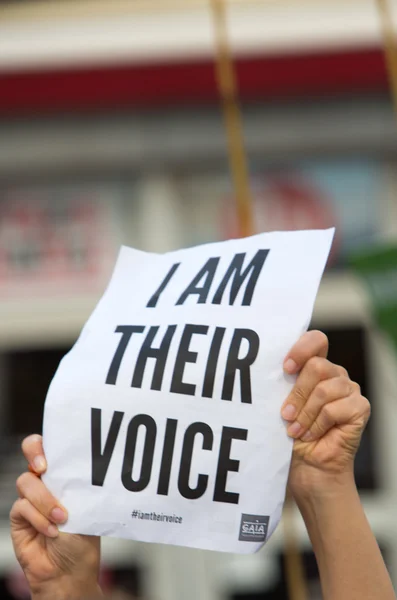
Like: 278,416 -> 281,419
282,331 -> 371,499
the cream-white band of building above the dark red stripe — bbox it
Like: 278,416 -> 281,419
0,0 -> 390,71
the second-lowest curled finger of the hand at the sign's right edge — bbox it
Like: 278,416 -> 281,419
288,376 -> 352,438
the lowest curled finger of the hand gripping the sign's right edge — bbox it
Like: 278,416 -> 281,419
302,393 -> 371,442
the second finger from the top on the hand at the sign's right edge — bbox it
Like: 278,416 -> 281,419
281,356 -> 343,430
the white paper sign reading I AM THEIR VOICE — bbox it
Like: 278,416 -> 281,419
44,229 -> 334,554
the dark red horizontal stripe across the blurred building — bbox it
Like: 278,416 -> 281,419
0,49 -> 387,115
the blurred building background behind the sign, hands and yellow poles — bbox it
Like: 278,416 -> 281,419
0,0 -> 397,600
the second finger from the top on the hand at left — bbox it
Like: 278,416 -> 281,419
17,473 -> 67,523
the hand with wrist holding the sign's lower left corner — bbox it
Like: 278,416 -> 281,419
10,435 -> 100,600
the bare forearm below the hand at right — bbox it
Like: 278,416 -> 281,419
298,475 -> 396,600
